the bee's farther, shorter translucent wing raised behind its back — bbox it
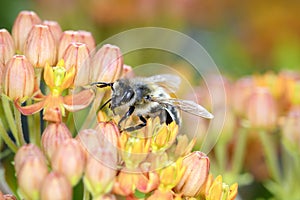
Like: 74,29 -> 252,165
144,74 -> 181,93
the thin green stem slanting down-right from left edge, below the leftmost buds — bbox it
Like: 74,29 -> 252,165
2,96 -> 21,146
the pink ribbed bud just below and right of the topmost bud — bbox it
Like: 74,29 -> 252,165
24,25 -> 57,68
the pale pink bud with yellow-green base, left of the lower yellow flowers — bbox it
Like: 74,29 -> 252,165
83,149 -> 117,197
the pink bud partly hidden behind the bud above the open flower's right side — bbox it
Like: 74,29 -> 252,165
58,30 -> 79,59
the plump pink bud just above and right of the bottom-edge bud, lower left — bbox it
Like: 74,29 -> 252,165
51,139 -> 85,186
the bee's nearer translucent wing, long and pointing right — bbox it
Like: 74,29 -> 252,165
153,98 -> 214,119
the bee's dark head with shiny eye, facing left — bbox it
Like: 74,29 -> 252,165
111,79 -> 135,110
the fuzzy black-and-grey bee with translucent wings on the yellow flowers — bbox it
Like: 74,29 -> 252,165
91,74 -> 213,132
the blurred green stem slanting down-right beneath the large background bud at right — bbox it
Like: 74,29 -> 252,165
259,129 -> 280,183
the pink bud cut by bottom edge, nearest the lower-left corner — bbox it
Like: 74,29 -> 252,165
17,156 -> 48,200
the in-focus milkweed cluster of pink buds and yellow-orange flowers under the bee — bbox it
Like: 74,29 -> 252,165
0,11 -> 237,200
